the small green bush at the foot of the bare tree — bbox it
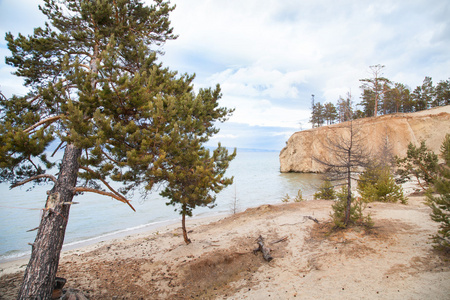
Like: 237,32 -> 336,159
331,186 -> 373,228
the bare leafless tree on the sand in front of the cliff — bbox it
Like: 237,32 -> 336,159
313,121 -> 371,227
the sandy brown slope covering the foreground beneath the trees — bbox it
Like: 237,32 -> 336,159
0,196 -> 450,299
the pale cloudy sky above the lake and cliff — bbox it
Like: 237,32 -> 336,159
0,0 -> 450,151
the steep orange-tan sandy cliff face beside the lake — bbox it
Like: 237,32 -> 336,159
280,105 -> 450,173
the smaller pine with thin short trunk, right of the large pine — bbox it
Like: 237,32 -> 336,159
156,86 -> 236,244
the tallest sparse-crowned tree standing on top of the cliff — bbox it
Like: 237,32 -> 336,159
359,65 -> 390,117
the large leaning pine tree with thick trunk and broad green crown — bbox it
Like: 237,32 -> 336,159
0,0 -> 232,299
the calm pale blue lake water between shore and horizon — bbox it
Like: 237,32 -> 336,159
0,149 -> 321,262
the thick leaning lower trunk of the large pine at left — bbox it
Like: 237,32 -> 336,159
18,145 -> 81,299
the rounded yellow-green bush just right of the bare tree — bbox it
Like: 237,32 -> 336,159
357,167 -> 407,204
